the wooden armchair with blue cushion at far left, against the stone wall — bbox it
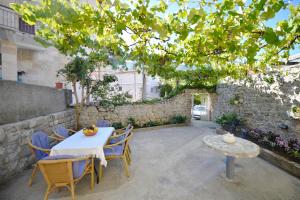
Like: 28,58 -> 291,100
28,131 -> 59,187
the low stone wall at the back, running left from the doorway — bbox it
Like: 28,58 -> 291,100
80,90 -> 216,127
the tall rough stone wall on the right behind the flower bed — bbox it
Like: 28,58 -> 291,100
213,65 -> 300,137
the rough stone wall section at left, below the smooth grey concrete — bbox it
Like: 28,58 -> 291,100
0,110 -> 75,183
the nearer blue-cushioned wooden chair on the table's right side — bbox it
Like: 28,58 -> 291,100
99,129 -> 133,177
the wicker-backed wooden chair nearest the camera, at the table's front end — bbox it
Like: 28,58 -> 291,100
38,156 -> 94,200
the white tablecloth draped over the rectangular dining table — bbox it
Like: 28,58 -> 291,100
50,127 -> 115,166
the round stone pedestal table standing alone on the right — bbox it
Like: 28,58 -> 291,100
203,135 -> 260,181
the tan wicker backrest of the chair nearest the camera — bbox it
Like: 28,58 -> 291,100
38,155 -> 88,184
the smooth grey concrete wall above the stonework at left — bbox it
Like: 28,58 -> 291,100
0,80 -> 71,125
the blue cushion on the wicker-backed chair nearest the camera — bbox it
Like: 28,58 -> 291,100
42,155 -> 86,179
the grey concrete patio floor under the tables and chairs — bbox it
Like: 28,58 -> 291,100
0,121 -> 300,200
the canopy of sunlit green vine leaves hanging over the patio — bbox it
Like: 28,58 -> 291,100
12,0 -> 300,86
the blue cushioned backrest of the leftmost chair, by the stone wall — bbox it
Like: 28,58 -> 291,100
31,131 -> 50,160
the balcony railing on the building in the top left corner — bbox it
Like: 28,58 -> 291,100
0,4 -> 35,35
